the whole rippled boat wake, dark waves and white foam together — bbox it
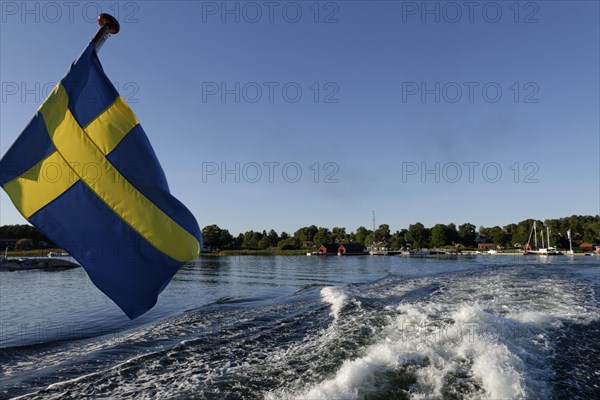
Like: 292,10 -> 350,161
0,266 -> 600,400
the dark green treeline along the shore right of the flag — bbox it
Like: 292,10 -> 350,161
202,215 -> 600,250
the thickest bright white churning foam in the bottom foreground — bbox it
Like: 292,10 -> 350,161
273,305 -> 526,400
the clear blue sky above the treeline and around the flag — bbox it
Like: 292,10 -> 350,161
0,1 -> 600,234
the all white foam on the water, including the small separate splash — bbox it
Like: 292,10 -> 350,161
278,273 -> 598,400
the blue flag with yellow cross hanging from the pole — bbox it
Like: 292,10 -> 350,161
0,43 -> 201,318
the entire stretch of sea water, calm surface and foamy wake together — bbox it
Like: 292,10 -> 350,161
0,255 -> 600,400
